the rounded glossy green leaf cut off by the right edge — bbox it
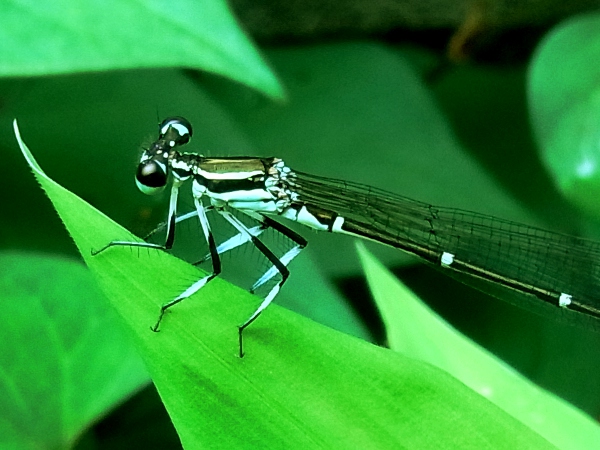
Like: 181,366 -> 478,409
528,14 -> 600,218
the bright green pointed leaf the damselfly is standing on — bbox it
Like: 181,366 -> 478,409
15,126 -> 552,449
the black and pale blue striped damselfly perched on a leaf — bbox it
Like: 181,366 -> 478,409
95,117 -> 600,356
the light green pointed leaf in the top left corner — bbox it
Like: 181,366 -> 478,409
0,0 -> 283,98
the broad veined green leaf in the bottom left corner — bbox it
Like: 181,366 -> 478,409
0,253 -> 148,449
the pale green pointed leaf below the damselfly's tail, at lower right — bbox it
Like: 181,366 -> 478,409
358,243 -> 600,450
